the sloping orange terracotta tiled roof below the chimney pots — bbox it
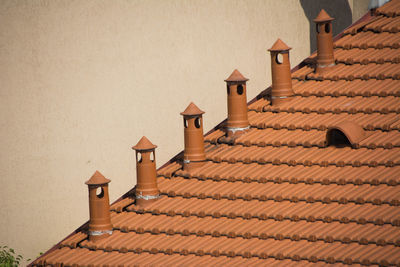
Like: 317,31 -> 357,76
33,0 -> 400,266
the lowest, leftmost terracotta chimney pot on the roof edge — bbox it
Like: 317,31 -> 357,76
85,171 -> 113,241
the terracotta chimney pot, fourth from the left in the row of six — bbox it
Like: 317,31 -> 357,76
225,69 -> 249,135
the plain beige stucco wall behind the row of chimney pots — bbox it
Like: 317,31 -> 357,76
0,0 -> 368,264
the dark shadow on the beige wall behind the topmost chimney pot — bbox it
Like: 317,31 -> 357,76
300,0 -> 352,53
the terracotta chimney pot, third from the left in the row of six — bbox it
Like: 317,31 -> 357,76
181,102 -> 206,171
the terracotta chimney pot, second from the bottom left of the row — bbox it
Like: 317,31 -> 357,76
132,136 -> 160,205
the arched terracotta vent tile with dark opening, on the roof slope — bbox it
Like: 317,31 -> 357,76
326,121 -> 367,148
